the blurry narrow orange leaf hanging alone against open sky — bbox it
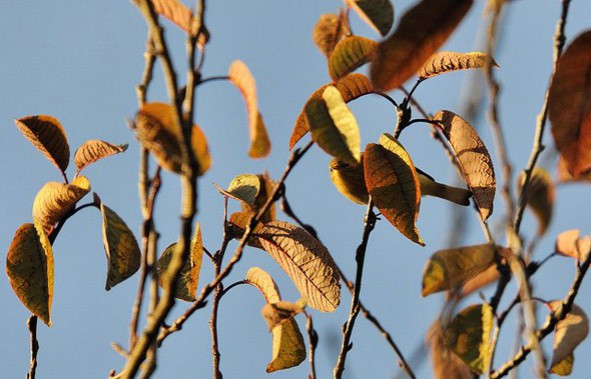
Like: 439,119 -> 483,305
228,61 -> 271,158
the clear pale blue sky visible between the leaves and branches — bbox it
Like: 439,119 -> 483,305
0,0 -> 591,378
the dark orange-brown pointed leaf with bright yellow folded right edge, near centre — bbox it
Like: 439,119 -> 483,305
364,134 -> 425,246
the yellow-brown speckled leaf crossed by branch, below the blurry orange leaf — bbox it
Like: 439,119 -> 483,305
158,223 -> 203,301
